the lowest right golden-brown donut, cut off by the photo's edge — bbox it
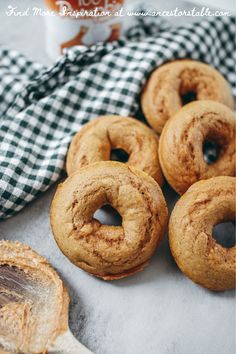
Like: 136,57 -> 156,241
169,176 -> 236,291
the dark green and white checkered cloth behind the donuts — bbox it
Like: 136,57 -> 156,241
0,17 -> 236,219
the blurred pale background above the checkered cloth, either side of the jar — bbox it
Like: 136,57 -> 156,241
0,0 -> 236,65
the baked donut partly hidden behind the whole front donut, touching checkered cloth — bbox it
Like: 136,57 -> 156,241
66,115 -> 163,185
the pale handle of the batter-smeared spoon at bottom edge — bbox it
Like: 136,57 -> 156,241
48,329 -> 93,354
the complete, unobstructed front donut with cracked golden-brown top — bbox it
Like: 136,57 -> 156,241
51,161 -> 168,280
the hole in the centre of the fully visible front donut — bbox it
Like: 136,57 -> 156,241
93,204 -> 122,226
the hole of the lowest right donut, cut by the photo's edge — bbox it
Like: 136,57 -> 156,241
212,221 -> 235,248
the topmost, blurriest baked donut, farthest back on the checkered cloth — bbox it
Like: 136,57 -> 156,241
141,59 -> 233,133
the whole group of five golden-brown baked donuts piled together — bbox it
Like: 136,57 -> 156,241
51,60 -> 236,290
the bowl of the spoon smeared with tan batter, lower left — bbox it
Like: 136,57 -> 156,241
0,241 -> 69,354
